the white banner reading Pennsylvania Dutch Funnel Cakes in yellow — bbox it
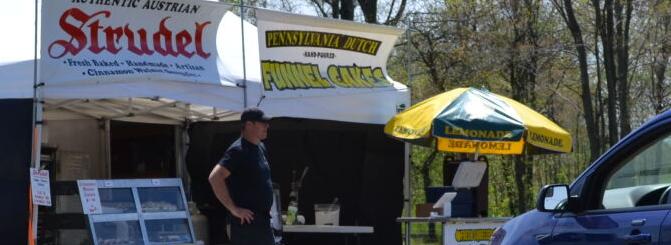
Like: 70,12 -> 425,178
256,9 -> 405,99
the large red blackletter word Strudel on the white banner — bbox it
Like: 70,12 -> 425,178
48,8 -> 211,59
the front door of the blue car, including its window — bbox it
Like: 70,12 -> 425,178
542,130 -> 671,244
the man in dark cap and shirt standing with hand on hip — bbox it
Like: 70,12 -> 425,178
209,108 -> 274,245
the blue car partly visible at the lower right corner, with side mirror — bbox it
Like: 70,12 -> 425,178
492,111 -> 671,245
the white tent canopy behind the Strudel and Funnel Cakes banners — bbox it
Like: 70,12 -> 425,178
0,9 -> 409,124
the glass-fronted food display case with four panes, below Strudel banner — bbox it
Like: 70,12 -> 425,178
78,179 -> 195,245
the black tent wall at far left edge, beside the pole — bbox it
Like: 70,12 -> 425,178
0,99 -> 33,244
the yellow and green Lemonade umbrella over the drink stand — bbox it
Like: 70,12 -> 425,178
384,88 -> 572,154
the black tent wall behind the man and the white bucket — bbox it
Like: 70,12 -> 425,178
186,118 -> 404,244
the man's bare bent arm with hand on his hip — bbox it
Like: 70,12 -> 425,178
208,164 -> 254,224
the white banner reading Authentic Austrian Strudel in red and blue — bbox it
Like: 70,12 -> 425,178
40,0 -> 230,85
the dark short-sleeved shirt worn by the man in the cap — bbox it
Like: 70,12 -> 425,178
218,137 -> 273,224
